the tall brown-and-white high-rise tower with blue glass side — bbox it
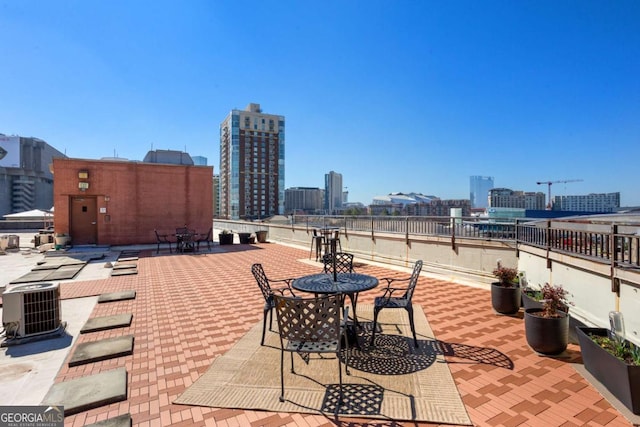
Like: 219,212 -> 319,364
219,104 -> 285,219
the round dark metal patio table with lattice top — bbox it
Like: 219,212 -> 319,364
291,273 -> 378,334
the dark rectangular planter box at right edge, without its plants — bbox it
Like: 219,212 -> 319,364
576,327 -> 640,415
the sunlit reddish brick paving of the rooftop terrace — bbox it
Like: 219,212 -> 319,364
50,243 -> 631,426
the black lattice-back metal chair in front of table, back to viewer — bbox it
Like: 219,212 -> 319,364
273,295 -> 349,403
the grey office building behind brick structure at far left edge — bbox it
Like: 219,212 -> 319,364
0,134 -> 66,216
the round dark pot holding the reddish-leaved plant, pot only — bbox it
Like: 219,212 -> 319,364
524,308 -> 569,355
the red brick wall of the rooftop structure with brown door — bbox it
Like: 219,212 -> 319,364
53,158 -> 213,245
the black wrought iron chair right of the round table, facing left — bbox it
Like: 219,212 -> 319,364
371,260 -> 422,348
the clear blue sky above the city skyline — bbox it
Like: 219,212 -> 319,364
0,0 -> 640,206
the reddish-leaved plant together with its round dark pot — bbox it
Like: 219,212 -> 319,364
524,283 -> 569,355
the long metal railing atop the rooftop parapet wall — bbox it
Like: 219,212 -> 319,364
291,215 -> 640,268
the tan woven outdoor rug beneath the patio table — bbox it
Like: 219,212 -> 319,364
174,304 -> 471,425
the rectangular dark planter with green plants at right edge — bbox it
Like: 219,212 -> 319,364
576,318 -> 640,415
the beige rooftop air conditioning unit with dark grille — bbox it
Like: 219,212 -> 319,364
2,283 -> 62,339
